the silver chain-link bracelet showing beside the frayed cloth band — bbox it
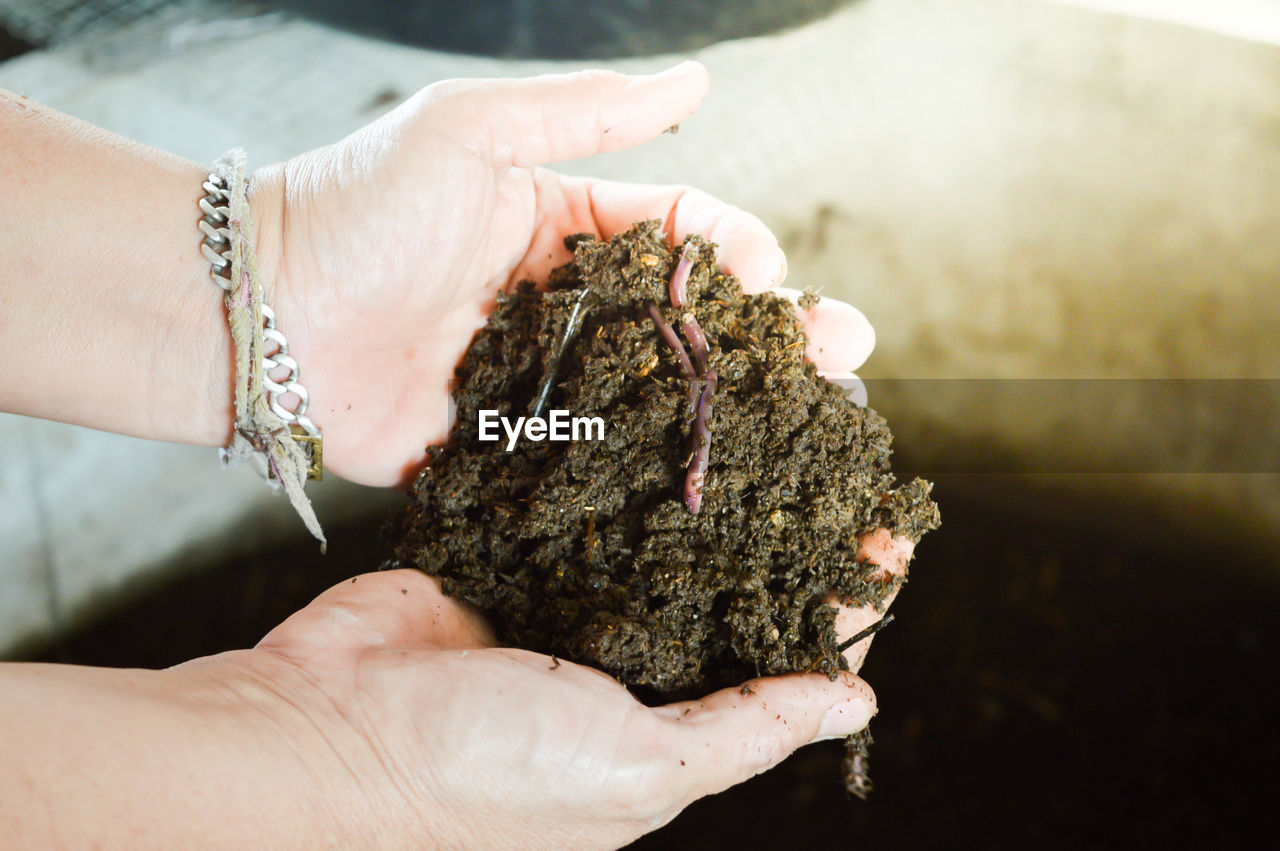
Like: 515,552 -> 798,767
200,174 -> 324,479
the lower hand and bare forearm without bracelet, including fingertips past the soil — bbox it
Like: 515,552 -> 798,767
0,532 -> 906,848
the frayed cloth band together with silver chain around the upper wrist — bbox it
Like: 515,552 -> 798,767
200,148 -> 325,552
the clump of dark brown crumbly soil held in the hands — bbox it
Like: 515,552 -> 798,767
392,221 -> 938,700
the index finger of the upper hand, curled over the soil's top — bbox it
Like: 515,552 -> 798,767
516,169 -> 787,293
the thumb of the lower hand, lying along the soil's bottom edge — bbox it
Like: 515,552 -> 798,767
654,673 -> 876,801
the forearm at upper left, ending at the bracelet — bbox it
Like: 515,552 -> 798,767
0,90 -> 275,445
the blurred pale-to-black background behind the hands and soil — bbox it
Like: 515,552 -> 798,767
0,0 -> 1280,848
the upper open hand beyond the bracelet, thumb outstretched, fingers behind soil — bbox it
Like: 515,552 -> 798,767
251,63 -> 874,485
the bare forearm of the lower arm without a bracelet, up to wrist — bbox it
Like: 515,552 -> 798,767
0,659 -> 349,848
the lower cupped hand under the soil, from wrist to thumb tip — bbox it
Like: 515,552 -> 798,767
174,555 -> 906,847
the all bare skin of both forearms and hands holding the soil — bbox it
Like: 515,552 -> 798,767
0,63 -> 910,848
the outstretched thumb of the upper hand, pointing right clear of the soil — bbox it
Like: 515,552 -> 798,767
421,61 -> 710,168
